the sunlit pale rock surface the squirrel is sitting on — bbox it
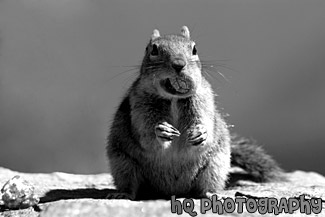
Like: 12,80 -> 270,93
0,168 -> 325,217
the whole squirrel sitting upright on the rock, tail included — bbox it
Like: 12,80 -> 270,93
106,26 -> 282,200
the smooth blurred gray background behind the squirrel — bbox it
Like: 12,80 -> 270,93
0,0 -> 325,174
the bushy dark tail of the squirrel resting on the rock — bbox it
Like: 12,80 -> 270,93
231,136 -> 285,182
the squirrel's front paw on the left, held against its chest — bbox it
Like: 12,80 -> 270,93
155,122 -> 181,144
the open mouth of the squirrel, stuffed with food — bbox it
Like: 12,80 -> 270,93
160,78 -> 192,95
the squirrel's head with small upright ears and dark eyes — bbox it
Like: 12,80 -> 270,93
140,26 -> 202,98
